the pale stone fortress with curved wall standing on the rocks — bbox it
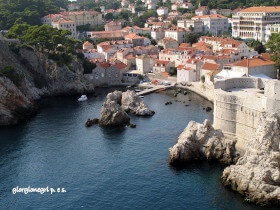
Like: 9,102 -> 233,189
214,77 -> 280,153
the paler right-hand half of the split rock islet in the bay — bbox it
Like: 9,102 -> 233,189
121,90 -> 155,116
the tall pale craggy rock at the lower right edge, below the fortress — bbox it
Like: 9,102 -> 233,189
222,114 -> 280,205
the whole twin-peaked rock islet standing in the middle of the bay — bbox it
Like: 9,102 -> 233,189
99,90 -> 155,126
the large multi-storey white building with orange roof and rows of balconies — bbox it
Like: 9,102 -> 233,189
232,6 -> 280,42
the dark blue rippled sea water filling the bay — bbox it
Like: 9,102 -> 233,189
0,89 -> 274,209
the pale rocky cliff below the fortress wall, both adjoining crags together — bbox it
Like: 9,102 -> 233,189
169,114 -> 280,205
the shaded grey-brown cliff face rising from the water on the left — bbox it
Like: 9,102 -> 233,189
0,34 -> 94,125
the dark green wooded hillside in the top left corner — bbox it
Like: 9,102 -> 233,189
0,0 -> 68,30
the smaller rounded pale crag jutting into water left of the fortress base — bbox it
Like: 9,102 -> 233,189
169,120 -> 236,165
